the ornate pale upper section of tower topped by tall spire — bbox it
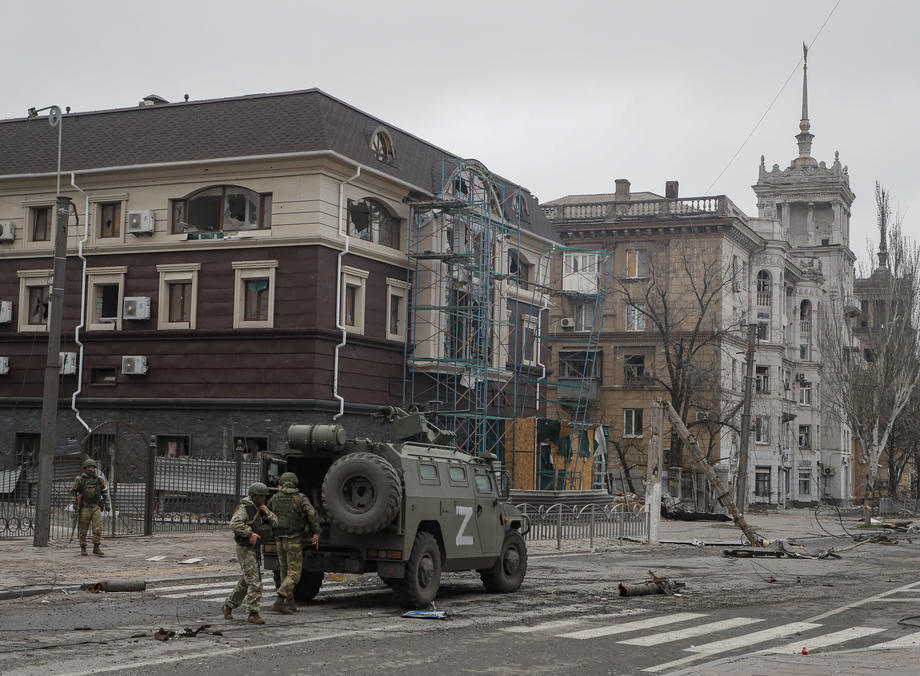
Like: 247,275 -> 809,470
751,43 -> 855,247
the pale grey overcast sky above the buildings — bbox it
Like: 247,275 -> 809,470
0,0 -> 920,262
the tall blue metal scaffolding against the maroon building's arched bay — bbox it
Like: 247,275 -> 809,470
403,160 -> 549,460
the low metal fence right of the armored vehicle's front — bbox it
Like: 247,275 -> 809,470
517,503 -> 648,549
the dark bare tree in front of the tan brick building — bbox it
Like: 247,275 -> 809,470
615,239 -> 736,466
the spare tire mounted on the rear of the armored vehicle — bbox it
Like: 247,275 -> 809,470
323,453 -> 402,535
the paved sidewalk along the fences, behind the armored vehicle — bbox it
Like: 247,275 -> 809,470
0,510 -> 855,599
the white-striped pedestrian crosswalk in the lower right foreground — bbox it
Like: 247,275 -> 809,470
502,613 -> 920,673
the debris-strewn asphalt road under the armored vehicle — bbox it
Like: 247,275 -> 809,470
0,542 -> 920,676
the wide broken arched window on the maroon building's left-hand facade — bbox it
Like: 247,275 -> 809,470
170,185 -> 272,234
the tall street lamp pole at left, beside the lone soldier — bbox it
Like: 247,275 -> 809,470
28,106 -> 71,547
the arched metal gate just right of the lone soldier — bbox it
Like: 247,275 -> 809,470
80,420 -> 151,536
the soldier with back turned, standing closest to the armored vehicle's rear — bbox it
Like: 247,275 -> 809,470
268,472 -> 320,615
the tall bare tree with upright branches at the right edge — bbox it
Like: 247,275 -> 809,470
817,183 -> 920,518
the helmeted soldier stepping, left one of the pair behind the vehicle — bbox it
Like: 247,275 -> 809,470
222,481 -> 278,624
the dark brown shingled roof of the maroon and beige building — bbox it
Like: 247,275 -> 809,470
0,89 -> 557,240
